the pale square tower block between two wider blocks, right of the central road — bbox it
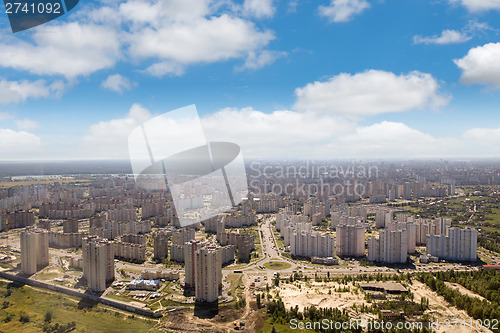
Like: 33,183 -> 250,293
336,224 -> 365,257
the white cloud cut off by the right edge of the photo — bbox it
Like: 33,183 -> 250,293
454,43 -> 500,89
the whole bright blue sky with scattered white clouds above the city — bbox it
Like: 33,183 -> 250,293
0,0 -> 500,160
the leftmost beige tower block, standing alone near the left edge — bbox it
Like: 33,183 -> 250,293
20,227 -> 49,275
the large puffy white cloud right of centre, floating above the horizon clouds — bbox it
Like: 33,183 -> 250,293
295,70 -> 449,116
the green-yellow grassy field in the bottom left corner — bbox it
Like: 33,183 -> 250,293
0,281 -> 155,333
